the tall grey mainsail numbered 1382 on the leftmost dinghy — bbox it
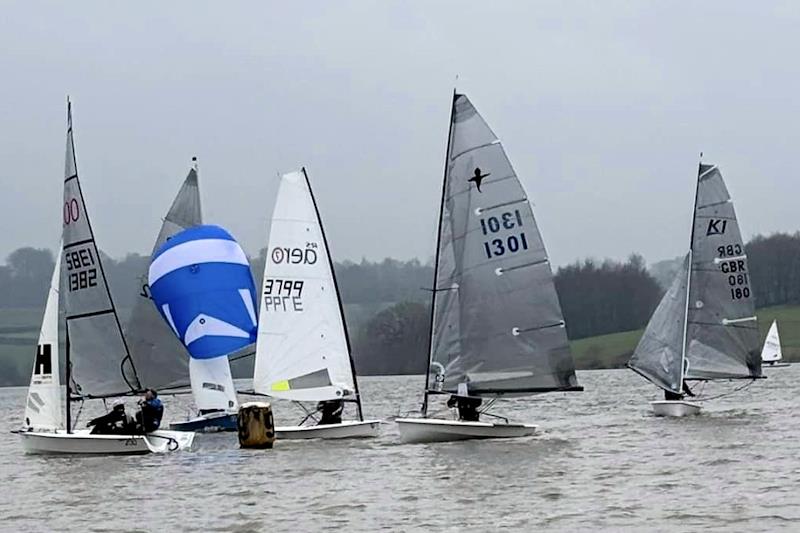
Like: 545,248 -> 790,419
60,102 -> 139,396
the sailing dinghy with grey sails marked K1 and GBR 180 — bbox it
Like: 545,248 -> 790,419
628,163 -> 761,416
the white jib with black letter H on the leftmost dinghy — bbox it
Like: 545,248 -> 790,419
25,251 -> 64,430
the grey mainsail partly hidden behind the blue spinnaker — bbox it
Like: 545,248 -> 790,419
126,169 -> 203,389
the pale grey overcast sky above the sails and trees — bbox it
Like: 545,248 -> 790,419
0,0 -> 800,265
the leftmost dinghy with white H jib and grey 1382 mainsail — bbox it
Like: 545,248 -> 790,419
17,104 -> 194,455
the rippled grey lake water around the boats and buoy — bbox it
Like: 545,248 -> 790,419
0,365 -> 800,532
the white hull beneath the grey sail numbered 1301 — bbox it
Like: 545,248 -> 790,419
396,418 -> 538,443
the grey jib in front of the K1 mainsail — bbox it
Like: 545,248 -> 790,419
628,254 -> 689,394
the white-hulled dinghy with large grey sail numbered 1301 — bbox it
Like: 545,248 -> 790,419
396,94 -> 583,442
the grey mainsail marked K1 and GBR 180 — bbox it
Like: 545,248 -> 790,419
685,165 -> 761,379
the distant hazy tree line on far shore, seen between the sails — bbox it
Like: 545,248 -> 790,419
0,233 -> 800,382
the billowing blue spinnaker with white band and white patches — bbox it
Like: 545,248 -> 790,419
148,225 -> 258,359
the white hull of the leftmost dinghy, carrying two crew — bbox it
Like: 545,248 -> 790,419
19,429 -> 194,455
